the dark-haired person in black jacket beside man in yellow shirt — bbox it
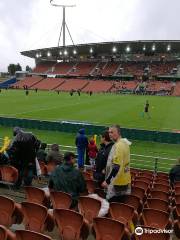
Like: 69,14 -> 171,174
94,131 -> 114,185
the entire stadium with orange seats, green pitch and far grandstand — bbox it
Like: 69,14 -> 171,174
0,1 -> 180,240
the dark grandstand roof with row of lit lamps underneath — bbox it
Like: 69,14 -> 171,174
21,40 -> 180,61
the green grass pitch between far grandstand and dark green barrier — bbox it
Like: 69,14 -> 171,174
0,90 -> 180,131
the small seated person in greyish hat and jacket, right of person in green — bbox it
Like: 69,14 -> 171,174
46,143 -> 63,165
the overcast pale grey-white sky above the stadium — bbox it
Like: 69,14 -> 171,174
0,0 -> 180,71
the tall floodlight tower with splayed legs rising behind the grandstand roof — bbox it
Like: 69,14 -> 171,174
50,0 -> 76,48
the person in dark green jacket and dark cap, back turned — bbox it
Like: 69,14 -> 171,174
49,152 -> 86,207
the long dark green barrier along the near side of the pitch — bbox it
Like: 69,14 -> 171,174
0,117 -> 180,144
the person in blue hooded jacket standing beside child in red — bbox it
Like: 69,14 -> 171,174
75,128 -> 88,168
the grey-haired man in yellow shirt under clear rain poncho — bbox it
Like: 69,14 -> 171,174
102,125 -> 131,202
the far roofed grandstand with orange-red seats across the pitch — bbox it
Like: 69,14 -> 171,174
6,41 -> 180,96
